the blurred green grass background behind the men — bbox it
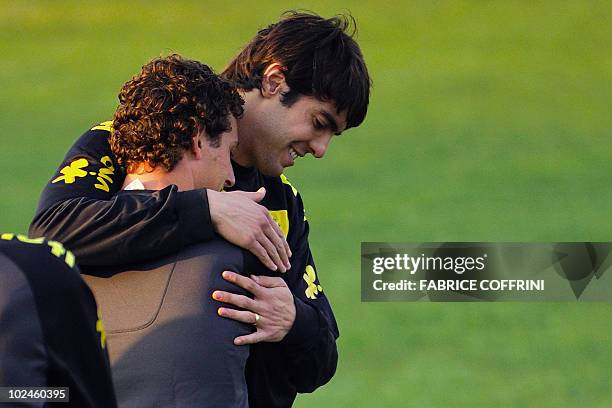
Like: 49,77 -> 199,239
0,0 -> 612,407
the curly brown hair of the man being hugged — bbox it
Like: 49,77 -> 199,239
110,54 -> 244,171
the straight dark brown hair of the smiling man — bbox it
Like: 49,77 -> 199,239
221,11 -> 371,128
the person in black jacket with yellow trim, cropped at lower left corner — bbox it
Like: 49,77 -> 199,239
0,233 -> 117,408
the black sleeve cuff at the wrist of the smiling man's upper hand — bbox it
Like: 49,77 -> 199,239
177,189 -> 215,246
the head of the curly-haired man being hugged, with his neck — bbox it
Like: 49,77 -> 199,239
110,54 -> 243,191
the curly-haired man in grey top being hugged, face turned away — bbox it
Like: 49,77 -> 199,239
83,54 -> 258,407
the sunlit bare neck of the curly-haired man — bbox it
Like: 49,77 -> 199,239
123,160 -> 195,191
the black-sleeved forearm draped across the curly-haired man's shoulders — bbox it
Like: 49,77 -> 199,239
30,186 -> 214,266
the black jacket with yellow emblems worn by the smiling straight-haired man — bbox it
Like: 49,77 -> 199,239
30,122 -> 339,408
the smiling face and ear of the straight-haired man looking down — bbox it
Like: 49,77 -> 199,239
234,65 -> 346,176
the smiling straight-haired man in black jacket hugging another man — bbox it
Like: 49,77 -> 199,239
30,13 -> 370,407
